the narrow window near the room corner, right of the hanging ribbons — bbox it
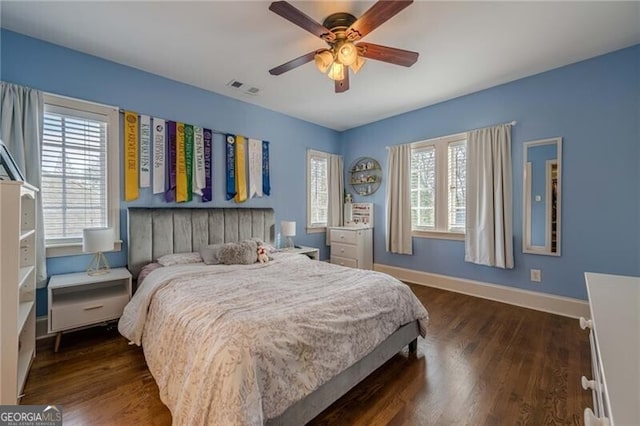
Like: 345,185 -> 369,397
307,149 -> 329,229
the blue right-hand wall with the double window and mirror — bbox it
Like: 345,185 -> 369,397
341,45 -> 640,299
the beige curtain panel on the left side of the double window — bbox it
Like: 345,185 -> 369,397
386,144 -> 413,254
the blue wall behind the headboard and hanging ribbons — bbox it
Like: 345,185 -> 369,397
0,30 -> 340,315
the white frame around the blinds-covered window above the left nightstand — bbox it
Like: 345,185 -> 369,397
44,93 -> 122,257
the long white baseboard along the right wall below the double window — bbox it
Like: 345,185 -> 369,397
373,263 -> 591,318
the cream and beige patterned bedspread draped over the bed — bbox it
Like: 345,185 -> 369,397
118,253 -> 428,425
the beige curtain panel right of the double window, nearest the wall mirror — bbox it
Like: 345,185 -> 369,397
464,124 -> 513,269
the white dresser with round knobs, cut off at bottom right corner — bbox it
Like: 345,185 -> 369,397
580,272 -> 640,426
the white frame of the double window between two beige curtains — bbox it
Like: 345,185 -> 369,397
411,133 -> 467,240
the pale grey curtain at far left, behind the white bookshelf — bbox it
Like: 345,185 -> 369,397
0,82 -> 47,288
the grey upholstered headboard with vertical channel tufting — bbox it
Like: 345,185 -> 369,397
128,207 -> 275,278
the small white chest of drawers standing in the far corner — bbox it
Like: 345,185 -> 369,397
330,227 -> 373,269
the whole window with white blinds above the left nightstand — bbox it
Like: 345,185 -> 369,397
41,95 -> 119,256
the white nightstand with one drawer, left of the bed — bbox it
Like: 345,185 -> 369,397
48,268 -> 131,352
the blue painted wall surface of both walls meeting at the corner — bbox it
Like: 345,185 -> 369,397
0,30 -> 640,315
